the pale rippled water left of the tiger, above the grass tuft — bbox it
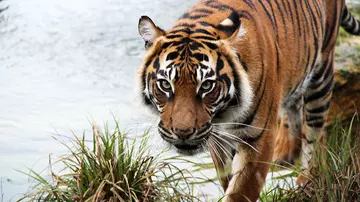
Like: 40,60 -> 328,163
0,0 -> 200,201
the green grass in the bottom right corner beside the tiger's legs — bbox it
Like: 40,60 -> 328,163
261,117 -> 360,202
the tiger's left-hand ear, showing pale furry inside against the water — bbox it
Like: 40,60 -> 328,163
138,16 -> 165,49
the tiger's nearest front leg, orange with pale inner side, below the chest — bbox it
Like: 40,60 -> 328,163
222,130 -> 274,202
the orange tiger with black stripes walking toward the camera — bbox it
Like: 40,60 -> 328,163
138,0 -> 360,202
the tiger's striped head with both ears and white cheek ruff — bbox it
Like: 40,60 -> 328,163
138,13 -> 252,153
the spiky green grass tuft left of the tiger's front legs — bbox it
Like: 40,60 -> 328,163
19,121 -> 198,202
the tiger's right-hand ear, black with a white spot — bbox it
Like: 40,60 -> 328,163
218,12 -> 241,41
